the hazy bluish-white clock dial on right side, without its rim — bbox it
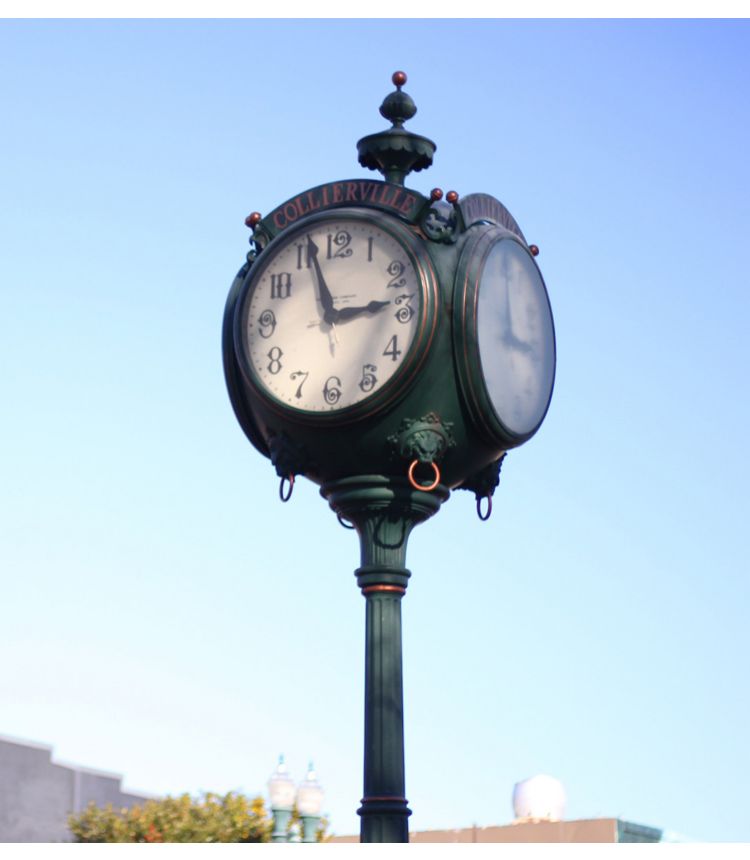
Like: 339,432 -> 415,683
476,239 -> 555,436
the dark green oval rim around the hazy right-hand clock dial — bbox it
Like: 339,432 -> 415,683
453,225 -> 557,449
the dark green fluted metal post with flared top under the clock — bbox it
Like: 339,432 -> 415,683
321,475 -> 449,842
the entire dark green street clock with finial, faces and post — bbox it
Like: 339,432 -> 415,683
223,72 -> 555,842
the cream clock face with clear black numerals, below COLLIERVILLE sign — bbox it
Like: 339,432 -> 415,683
235,210 -> 436,416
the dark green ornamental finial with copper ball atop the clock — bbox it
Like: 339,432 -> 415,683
357,72 -> 437,185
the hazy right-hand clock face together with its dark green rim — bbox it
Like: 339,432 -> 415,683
455,227 -> 555,445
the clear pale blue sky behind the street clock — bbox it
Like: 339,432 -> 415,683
0,20 -> 750,841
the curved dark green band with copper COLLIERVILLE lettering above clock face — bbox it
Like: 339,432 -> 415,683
264,180 -> 418,230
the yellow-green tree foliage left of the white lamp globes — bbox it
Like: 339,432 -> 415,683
68,792 -> 273,842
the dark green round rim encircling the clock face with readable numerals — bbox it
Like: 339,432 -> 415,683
234,207 -> 438,425
